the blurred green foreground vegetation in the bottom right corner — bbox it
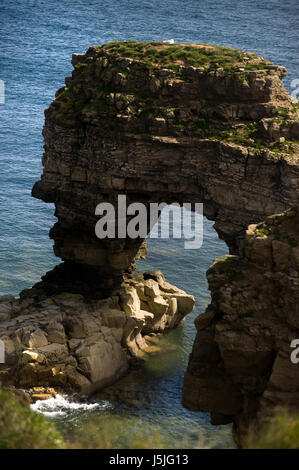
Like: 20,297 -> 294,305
244,410 -> 299,449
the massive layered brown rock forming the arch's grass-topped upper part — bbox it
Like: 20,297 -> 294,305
33,44 -> 299,280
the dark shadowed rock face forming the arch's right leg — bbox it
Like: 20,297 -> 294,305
183,209 -> 299,443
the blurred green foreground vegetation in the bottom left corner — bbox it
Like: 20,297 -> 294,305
0,390 -> 166,449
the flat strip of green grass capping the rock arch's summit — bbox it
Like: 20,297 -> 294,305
103,41 -> 270,71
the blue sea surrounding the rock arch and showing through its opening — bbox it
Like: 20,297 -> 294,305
0,0 -> 299,448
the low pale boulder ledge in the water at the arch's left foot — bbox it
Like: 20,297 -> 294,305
0,266 -> 194,393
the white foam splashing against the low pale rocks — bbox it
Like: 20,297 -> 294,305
31,394 -> 111,418
